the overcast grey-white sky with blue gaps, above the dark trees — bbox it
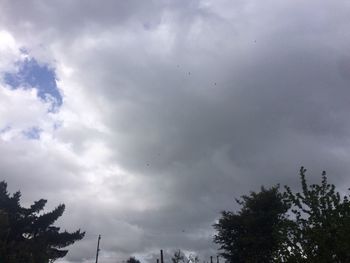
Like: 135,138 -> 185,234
0,0 -> 350,263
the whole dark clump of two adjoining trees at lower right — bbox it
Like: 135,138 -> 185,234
214,167 -> 350,263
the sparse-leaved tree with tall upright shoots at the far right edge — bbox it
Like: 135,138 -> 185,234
284,167 -> 350,263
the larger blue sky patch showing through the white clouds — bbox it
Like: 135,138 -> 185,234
4,58 -> 62,108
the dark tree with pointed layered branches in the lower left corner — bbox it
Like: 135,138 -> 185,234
0,182 -> 85,263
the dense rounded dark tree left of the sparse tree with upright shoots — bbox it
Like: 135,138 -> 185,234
214,186 -> 289,263
